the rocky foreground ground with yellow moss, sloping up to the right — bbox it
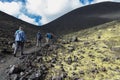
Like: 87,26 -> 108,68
0,21 -> 120,80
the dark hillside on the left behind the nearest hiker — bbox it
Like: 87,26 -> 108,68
0,12 -> 39,51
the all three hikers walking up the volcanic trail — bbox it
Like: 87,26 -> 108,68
13,27 -> 54,57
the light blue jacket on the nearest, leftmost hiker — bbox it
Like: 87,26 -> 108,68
15,30 -> 26,42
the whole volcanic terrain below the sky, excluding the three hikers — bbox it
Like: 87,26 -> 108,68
0,2 -> 120,80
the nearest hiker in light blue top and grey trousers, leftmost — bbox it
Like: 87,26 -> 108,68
14,27 -> 26,56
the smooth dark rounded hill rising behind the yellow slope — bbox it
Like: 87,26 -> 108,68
42,2 -> 120,35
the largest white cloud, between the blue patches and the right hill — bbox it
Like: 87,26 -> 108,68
26,0 -> 82,24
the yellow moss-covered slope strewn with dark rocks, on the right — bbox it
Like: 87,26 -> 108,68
43,21 -> 120,80
